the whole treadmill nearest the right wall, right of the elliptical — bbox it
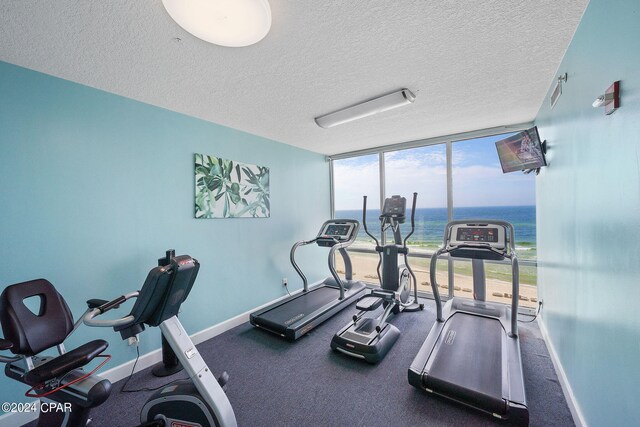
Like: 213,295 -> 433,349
409,220 -> 529,426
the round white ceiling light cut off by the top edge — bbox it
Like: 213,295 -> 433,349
162,0 -> 271,47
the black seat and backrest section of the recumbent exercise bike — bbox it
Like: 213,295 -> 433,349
0,279 -> 111,427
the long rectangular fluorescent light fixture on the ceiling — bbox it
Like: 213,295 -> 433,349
315,89 -> 416,129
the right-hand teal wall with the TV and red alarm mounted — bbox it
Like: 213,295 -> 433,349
536,0 -> 640,426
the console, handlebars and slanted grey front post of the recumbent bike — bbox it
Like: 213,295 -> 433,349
83,255 -> 237,427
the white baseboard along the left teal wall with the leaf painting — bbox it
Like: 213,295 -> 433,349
0,289 -> 302,427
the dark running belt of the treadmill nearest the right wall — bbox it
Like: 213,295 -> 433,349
423,313 -> 506,414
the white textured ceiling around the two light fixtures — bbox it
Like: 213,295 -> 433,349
0,0 -> 588,154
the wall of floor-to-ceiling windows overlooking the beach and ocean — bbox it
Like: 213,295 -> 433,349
332,127 -> 537,308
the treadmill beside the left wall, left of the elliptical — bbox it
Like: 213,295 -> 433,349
249,219 -> 367,341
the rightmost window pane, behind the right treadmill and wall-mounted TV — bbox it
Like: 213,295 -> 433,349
451,135 -> 537,307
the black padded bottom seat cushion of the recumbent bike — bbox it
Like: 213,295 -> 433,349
22,340 -> 109,386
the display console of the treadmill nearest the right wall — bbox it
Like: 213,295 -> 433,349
446,222 -> 507,259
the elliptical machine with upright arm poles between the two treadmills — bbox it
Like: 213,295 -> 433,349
331,193 -> 424,363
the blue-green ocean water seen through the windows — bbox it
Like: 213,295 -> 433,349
336,206 -> 536,258
